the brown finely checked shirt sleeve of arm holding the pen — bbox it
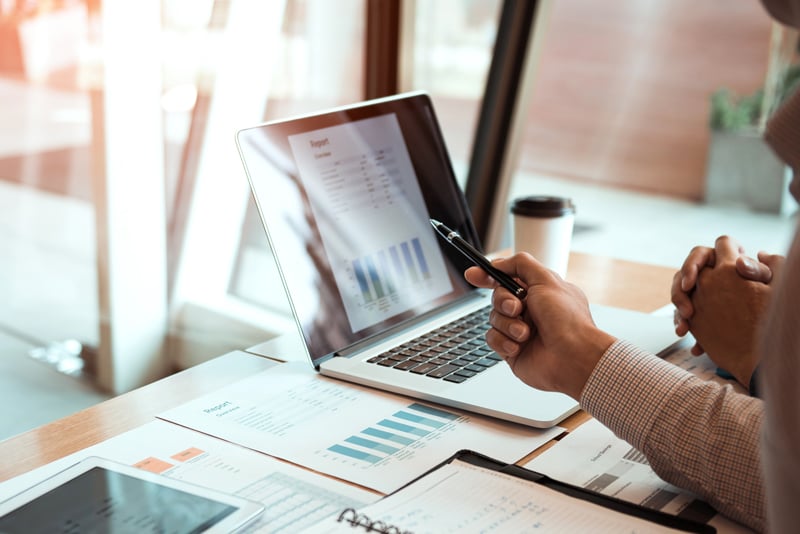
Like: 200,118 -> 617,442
581,341 -> 766,531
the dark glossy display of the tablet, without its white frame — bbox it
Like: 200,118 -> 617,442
0,467 -> 237,534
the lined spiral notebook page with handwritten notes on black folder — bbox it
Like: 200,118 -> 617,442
307,460 -> 692,534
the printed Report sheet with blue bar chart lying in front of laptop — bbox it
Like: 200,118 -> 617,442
159,363 -> 563,493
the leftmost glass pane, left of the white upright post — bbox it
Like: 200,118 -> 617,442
0,1 -> 106,439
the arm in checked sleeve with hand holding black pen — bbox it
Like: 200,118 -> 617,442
465,254 -> 764,528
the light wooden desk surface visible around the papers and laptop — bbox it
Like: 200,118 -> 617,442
0,253 -> 675,481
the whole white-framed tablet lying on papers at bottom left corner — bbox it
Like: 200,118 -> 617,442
0,457 -> 264,534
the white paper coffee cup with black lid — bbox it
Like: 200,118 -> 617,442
511,196 -> 575,277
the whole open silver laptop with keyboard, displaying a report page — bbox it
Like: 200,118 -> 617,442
236,92 -> 675,428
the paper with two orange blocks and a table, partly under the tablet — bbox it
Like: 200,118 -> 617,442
0,420 -> 380,532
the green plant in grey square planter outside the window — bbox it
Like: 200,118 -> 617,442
705,24 -> 800,215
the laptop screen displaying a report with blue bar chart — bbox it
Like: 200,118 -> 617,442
237,93 -> 476,364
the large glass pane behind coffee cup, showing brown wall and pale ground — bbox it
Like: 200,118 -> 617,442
506,0 -> 791,268
